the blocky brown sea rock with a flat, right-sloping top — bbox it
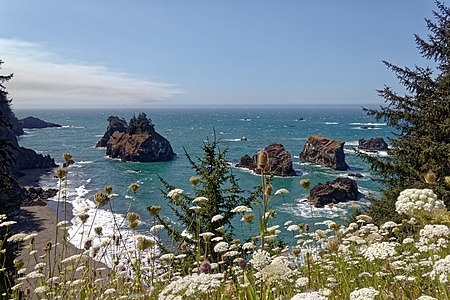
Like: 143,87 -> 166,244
300,136 -> 349,171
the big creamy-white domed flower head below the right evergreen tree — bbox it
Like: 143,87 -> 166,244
395,189 -> 445,216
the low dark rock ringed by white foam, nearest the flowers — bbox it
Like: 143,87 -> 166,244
308,178 -> 359,207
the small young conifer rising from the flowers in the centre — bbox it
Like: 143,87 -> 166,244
158,139 -> 251,260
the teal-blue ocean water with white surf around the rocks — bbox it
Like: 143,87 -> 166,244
15,107 -> 392,248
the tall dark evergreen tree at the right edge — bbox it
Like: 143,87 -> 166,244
364,1 -> 450,221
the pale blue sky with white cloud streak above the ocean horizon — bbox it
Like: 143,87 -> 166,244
0,0 -> 436,109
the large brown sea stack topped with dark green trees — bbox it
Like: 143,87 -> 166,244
97,113 -> 176,162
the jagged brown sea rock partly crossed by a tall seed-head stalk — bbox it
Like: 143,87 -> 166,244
236,143 -> 297,176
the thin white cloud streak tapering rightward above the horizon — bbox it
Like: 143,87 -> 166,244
0,39 -> 181,108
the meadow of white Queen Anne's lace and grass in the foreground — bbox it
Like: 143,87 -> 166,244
0,152 -> 450,300
